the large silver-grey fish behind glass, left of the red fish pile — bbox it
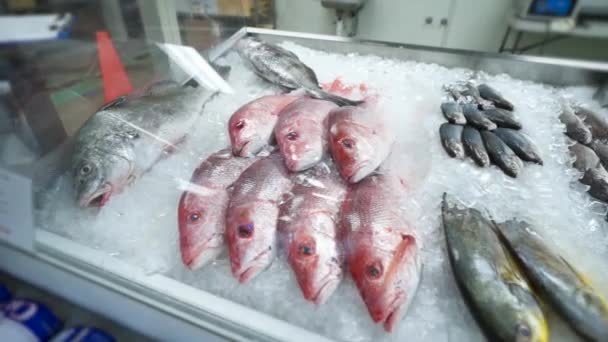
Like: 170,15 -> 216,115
71,82 -> 213,207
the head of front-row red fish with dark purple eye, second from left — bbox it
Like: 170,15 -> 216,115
226,201 -> 278,283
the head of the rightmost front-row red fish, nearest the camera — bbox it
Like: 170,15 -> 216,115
349,233 -> 420,332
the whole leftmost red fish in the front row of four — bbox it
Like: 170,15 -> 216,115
177,149 -> 256,270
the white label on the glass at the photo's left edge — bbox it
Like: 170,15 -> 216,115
0,168 -> 34,250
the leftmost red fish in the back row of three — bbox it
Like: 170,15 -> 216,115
228,95 -> 300,157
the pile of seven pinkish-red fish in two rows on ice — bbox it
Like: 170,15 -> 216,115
178,91 -> 421,331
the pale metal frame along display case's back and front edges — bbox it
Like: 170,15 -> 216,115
0,27 -> 608,341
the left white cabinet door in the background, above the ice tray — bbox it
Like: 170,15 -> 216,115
357,0 -> 452,46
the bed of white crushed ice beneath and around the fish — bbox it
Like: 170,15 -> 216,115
38,42 -> 608,341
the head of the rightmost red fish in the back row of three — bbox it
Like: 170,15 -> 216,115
329,114 -> 385,183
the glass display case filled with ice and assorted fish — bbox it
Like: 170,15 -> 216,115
0,0 -> 608,341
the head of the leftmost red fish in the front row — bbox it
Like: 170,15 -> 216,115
177,192 -> 227,270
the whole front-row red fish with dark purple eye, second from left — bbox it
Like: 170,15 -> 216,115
226,153 -> 292,283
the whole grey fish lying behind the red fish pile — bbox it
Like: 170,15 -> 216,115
237,37 -> 363,106
